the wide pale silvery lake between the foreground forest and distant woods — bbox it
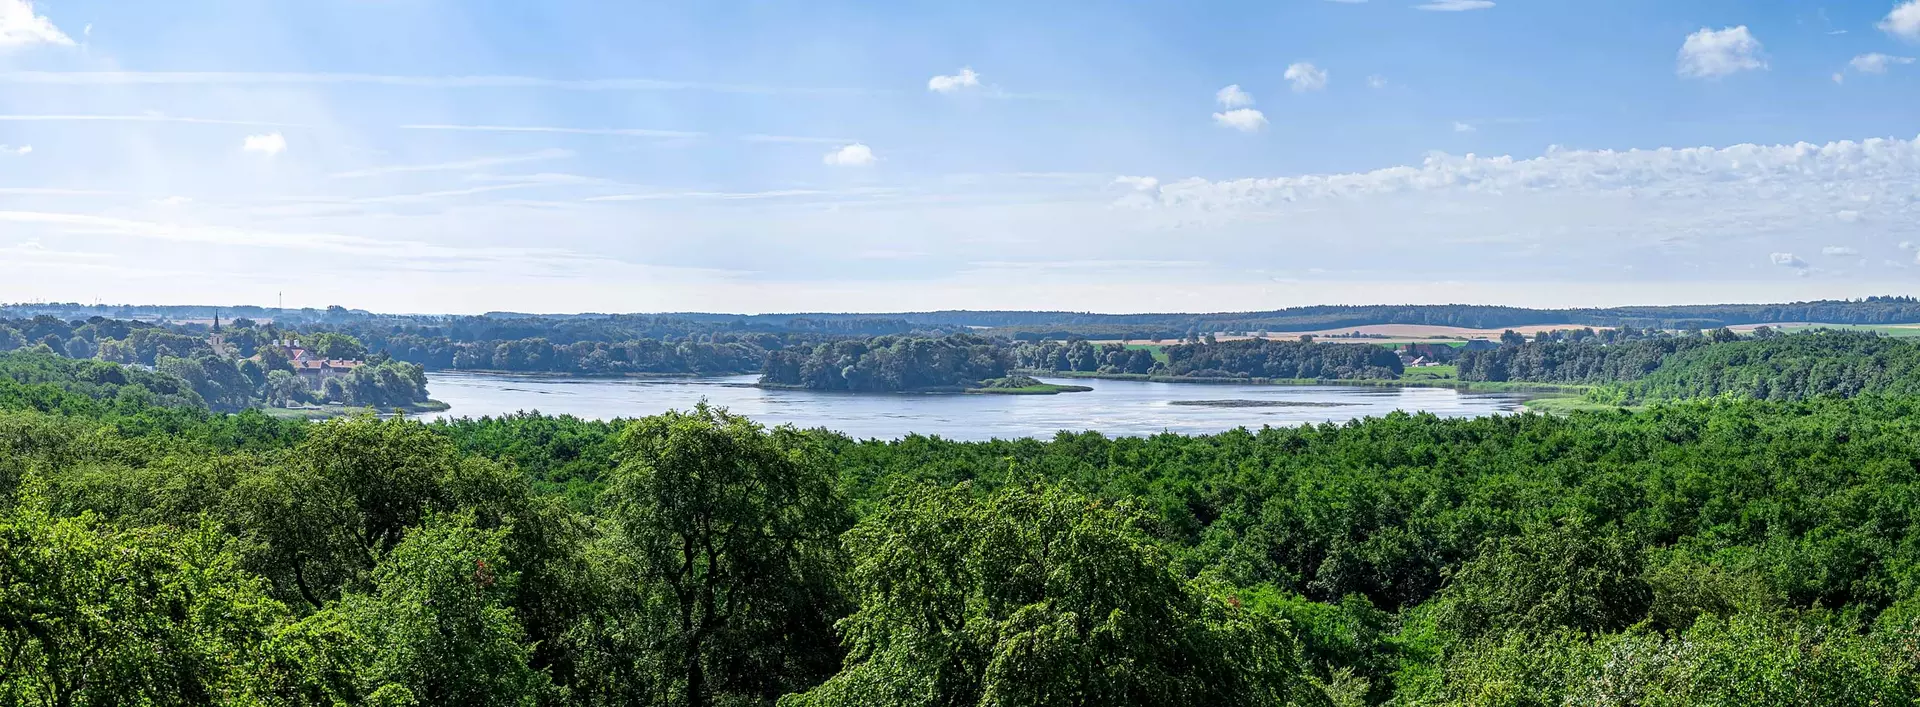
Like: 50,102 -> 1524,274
419,373 -> 1523,440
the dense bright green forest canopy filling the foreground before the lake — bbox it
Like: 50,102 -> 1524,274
11,345 -> 1920,705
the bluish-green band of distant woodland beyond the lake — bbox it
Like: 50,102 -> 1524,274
15,307 -> 1920,411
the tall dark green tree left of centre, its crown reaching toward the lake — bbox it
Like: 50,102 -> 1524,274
607,403 -> 849,707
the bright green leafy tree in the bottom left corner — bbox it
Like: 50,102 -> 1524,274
0,496 -> 286,707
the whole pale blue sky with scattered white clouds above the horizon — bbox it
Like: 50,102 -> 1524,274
0,0 -> 1920,311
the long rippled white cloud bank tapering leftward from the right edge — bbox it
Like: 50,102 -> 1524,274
1127,138 -> 1920,243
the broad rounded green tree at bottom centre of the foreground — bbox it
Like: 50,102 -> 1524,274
781,486 -> 1315,707
